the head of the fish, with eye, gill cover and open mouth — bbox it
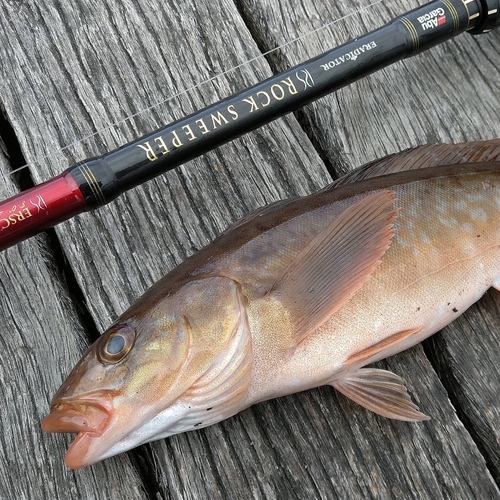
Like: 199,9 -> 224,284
42,277 -> 250,469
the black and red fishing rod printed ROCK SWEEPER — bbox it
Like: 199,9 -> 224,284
0,0 -> 500,251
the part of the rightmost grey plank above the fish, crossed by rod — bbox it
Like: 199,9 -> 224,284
238,0 -> 500,170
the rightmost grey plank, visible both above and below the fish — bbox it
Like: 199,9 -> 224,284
239,0 -> 500,484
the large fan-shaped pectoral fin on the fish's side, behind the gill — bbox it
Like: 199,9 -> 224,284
268,191 -> 397,347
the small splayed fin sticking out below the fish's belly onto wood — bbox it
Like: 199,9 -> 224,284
332,368 -> 429,422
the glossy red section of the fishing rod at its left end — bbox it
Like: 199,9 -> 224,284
0,172 -> 87,251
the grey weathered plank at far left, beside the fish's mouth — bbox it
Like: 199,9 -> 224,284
0,145 -> 144,500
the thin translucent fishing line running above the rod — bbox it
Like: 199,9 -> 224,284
0,0 -> 384,179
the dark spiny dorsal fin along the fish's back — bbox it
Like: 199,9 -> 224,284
324,139 -> 500,191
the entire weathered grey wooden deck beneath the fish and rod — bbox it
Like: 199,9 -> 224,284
0,0 -> 500,500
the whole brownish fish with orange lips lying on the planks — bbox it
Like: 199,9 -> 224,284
42,140 -> 500,469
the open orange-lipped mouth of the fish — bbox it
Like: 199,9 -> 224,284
42,395 -> 112,469
